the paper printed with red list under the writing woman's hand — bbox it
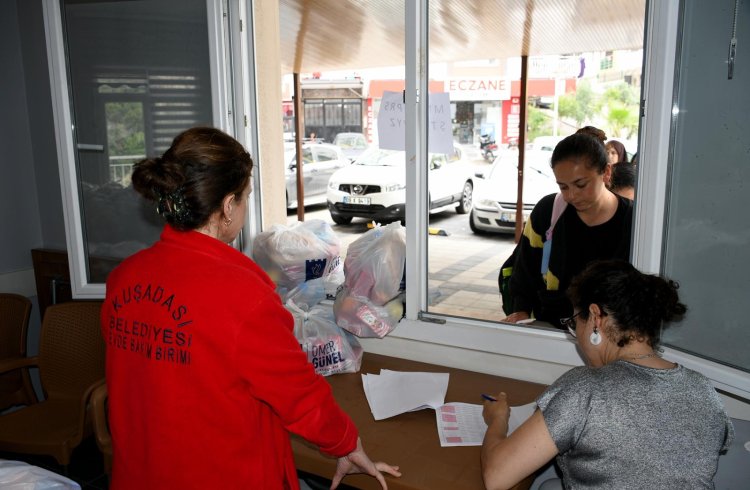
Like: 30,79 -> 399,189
435,403 -> 536,447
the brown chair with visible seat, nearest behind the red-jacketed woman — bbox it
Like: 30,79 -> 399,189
0,301 -> 105,466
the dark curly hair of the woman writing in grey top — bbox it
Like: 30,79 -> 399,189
567,260 -> 687,347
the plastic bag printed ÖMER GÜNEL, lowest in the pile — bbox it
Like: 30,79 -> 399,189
286,301 -> 364,376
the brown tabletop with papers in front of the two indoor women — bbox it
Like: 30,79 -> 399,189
292,353 -> 545,490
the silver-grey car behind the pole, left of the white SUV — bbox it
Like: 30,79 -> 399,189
284,143 -> 351,209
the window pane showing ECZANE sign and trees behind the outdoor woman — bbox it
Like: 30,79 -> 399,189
427,0 -> 645,321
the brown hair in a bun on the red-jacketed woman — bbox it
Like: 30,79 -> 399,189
131,127 -> 253,231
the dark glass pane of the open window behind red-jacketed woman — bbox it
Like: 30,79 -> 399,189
64,0 -> 213,283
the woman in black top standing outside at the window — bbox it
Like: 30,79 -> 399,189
504,130 -> 633,328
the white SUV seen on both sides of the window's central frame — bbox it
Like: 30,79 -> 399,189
328,148 -> 474,225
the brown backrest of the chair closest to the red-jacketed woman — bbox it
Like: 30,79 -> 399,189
39,301 -> 105,399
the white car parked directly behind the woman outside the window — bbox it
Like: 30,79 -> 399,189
469,150 -> 560,233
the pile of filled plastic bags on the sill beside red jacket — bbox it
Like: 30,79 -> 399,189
253,220 -> 406,376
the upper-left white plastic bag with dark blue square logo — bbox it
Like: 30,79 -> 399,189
253,219 -> 342,294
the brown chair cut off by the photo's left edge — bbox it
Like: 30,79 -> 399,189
0,293 -> 37,411
